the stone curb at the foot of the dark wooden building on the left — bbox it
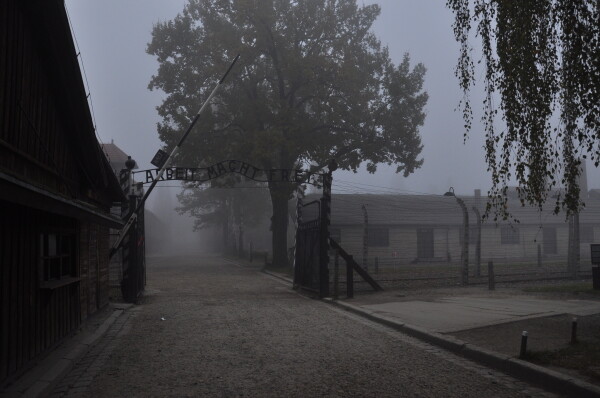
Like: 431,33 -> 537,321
21,309 -> 124,398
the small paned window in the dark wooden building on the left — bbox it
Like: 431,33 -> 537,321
40,233 -> 75,282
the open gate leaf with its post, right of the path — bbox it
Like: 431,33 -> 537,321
294,173 -> 335,297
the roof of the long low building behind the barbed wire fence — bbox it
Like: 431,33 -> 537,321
303,193 -> 600,226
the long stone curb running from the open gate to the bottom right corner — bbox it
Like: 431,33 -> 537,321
326,298 -> 600,398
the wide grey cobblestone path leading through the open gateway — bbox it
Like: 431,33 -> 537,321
53,257 -> 555,397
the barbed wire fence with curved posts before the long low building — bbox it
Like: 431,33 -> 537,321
318,179 -> 600,291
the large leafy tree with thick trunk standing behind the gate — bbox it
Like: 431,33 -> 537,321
147,0 -> 427,266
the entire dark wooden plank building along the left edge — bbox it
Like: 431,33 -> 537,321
0,0 -> 125,385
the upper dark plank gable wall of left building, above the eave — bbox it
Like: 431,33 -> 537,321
0,1 -> 80,196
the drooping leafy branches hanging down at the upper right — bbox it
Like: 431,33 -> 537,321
447,0 -> 600,218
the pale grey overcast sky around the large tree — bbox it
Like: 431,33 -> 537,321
66,0 -> 597,205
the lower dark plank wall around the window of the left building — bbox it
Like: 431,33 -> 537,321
0,201 -> 109,385
